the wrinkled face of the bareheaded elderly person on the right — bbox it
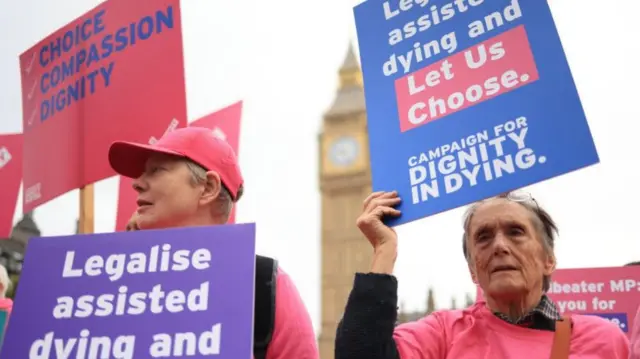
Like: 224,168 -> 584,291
467,199 -> 555,296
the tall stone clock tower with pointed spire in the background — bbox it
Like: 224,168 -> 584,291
319,46 -> 372,359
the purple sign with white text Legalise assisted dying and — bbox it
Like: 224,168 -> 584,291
0,224 -> 255,359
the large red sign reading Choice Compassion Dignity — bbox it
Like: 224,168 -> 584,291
20,0 -> 186,212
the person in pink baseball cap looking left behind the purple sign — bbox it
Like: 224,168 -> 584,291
109,127 -> 319,359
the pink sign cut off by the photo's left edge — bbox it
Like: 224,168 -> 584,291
0,134 -> 22,238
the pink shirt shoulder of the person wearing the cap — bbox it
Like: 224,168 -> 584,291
267,268 -> 320,359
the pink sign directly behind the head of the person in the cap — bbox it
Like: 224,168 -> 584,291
116,101 -> 242,231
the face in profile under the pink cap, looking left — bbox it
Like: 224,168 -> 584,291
133,155 -> 203,229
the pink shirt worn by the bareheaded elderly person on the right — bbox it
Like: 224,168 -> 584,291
394,302 -> 629,359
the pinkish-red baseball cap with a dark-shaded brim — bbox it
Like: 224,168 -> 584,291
109,127 -> 244,200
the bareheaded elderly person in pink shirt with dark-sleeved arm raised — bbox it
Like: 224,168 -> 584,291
335,192 -> 629,359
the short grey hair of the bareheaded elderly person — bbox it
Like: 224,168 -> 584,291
462,193 -> 558,293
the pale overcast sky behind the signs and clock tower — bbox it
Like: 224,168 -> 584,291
0,0 -> 640,338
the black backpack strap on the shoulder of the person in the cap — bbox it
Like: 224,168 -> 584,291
253,255 -> 278,359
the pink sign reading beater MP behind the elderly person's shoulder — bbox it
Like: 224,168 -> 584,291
477,266 -> 640,336
